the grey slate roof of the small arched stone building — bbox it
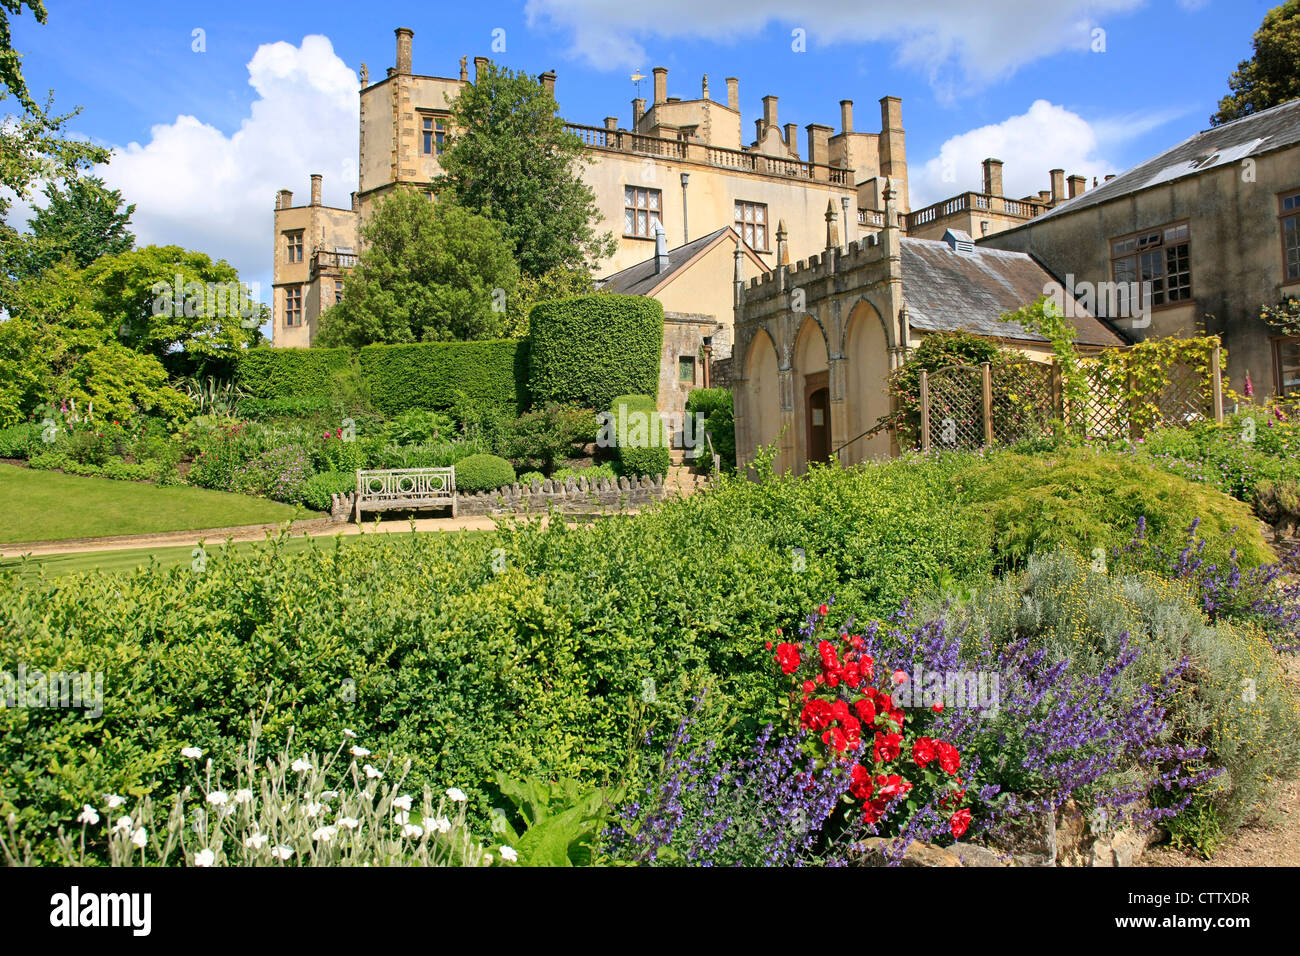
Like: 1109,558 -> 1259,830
898,230 -> 1125,346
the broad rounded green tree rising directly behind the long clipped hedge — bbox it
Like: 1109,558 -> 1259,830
317,189 -> 519,347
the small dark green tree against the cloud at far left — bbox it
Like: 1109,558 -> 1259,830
30,176 -> 135,269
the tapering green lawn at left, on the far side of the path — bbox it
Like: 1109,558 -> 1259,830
0,464 -> 301,544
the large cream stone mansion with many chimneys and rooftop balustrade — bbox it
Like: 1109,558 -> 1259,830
272,27 -> 907,346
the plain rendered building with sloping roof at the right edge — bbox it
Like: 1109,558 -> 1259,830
980,100 -> 1300,395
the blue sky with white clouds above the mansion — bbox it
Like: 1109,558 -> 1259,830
2,0 -> 1270,290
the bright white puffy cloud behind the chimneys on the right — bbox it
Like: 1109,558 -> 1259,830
909,100 -> 1187,208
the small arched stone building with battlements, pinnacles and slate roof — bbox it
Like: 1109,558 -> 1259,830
732,193 -> 1125,473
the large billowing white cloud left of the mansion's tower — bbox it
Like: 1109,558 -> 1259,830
100,35 -> 360,299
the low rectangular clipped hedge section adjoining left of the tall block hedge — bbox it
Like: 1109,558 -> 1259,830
358,339 -> 528,415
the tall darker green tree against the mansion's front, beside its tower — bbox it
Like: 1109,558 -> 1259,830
437,64 -> 615,278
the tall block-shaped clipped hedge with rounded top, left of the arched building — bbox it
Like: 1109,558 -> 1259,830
528,294 -> 663,408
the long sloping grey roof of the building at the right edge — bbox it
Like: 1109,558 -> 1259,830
1008,99 -> 1300,232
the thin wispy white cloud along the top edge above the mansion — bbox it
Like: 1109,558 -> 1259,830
525,0 -> 1145,96
